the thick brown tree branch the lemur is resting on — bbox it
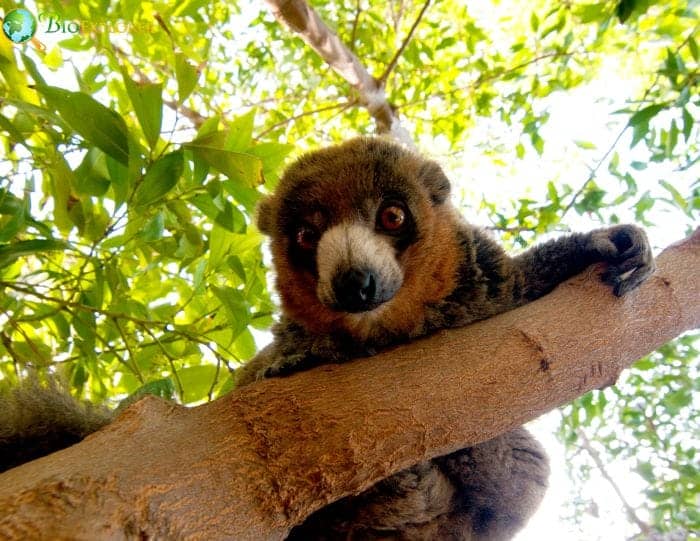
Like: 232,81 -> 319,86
0,230 -> 700,540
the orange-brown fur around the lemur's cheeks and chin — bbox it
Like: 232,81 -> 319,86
272,202 -> 460,340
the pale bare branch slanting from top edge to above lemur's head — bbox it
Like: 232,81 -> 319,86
265,0 -> 415,148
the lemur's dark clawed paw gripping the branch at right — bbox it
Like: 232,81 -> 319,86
591,225 -> 656,297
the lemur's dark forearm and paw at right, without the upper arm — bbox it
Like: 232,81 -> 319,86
512,221 -> 655,304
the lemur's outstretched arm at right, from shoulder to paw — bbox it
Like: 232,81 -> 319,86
434,225 -> 654,332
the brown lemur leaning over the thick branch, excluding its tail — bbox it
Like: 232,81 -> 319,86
238,139 -> 653,540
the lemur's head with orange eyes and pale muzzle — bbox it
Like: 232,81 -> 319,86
258,138 -> 458,339
